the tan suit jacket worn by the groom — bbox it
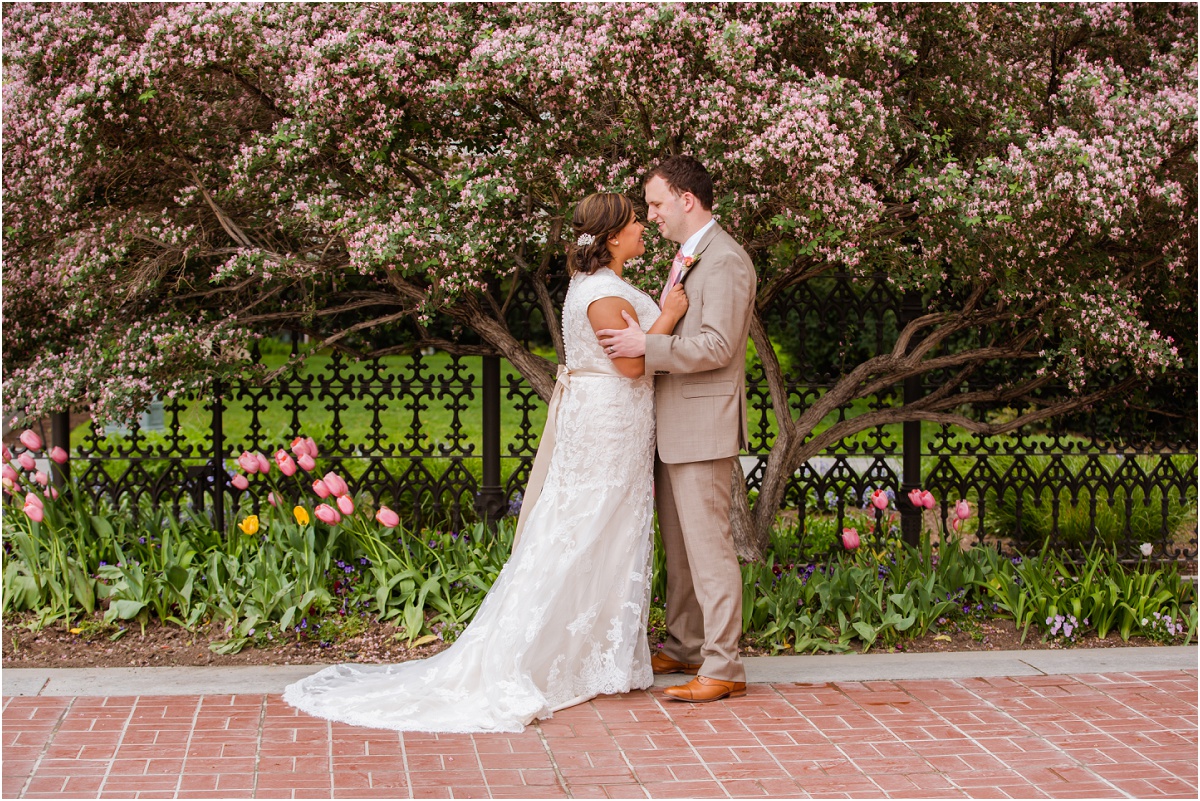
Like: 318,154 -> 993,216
646,225 -> 757,464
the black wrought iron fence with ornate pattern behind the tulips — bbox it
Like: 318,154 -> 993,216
30,276 -> 1196,559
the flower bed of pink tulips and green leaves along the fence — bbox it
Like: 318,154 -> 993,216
4,433 -> 1196,655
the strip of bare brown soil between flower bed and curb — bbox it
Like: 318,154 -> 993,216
4,615 -> 1154,668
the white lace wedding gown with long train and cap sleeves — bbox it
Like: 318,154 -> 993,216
283,269 -> 659,733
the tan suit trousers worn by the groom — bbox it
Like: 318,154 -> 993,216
654,456 -> 746,681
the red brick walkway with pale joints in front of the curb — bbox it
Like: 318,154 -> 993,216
4,670 -> 1198,799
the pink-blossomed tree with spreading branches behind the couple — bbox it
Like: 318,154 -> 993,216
4,4 -> 1196,553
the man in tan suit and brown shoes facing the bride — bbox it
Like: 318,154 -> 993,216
596,156 -> 757,703
